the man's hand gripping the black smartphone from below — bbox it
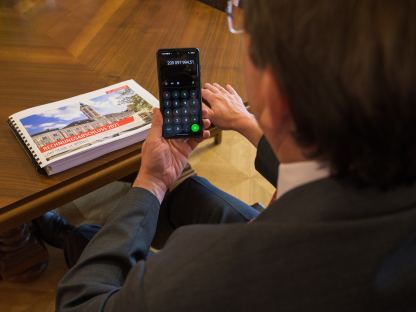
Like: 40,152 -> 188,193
133,109 -> 210,202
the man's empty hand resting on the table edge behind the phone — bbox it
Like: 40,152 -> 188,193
202,83 -> 263,146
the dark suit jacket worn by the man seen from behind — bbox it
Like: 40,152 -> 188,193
57,139 -> 416,312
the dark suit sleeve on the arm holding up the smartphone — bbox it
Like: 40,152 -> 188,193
56,188 -> 160,312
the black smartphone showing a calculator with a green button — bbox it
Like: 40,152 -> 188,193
157,48 -> 204,139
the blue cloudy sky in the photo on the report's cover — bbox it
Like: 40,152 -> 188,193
20,90 -> 132,136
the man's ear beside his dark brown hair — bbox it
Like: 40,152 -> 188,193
258,68 -> 291,134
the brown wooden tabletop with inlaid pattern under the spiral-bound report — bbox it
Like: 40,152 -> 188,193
0,0 -> 245,230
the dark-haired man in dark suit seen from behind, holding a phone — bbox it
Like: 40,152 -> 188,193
57,0 -> 416,312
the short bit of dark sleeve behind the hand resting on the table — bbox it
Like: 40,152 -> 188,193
254,136 -> 280,186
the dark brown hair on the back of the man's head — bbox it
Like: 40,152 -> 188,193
244,0 -> 416,189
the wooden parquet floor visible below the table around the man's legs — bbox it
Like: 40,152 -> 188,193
0,132 -> 274,312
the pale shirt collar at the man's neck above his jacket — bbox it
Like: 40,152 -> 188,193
277,161 -> 330,199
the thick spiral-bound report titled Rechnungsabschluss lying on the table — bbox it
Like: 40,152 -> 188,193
8,80 -> 159,175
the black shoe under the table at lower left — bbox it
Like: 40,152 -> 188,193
33,211 -> 75,249
